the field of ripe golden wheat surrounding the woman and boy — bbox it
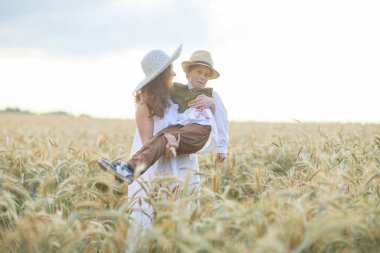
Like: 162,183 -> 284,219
0,113 -> 380,253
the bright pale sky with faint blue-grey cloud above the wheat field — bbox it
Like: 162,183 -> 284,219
0,0 -> 380,122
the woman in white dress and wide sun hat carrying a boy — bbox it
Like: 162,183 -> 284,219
128,46 -> 214,230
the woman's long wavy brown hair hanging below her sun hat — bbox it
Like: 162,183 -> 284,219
135,65 -> 172,118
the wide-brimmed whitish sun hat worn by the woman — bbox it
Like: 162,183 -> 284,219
133,44 -> 182,95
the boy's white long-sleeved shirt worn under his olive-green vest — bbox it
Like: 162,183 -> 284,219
187,83 -> 229,154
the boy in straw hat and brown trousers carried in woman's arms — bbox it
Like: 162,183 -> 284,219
98,51 -> 228,183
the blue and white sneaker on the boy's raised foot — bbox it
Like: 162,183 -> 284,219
98,159 -> 133,183
